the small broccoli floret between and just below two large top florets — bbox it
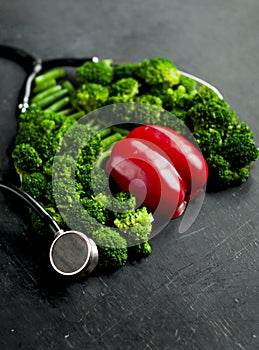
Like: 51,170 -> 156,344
110,78 -> 139,98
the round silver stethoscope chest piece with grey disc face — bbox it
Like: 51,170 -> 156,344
49,231 -> 98,276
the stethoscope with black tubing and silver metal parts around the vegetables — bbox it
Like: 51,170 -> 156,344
0,45 -> 223,276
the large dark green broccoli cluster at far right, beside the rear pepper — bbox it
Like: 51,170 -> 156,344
185,87 -> 259,191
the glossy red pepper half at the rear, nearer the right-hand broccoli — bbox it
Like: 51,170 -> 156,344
127,125 -> 208,200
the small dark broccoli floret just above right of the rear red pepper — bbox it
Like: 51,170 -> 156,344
193,128 -> 222,158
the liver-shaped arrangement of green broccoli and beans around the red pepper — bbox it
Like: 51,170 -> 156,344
12,58 -> 259,271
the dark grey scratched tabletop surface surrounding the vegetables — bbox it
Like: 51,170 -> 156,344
0,0 -> 259,350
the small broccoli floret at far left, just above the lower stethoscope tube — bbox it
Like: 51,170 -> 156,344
21,173 -> 47,200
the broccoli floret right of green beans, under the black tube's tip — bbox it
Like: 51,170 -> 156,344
76,59 -> 113,85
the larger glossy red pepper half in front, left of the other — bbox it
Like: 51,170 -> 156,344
106,138 -> 186,219
